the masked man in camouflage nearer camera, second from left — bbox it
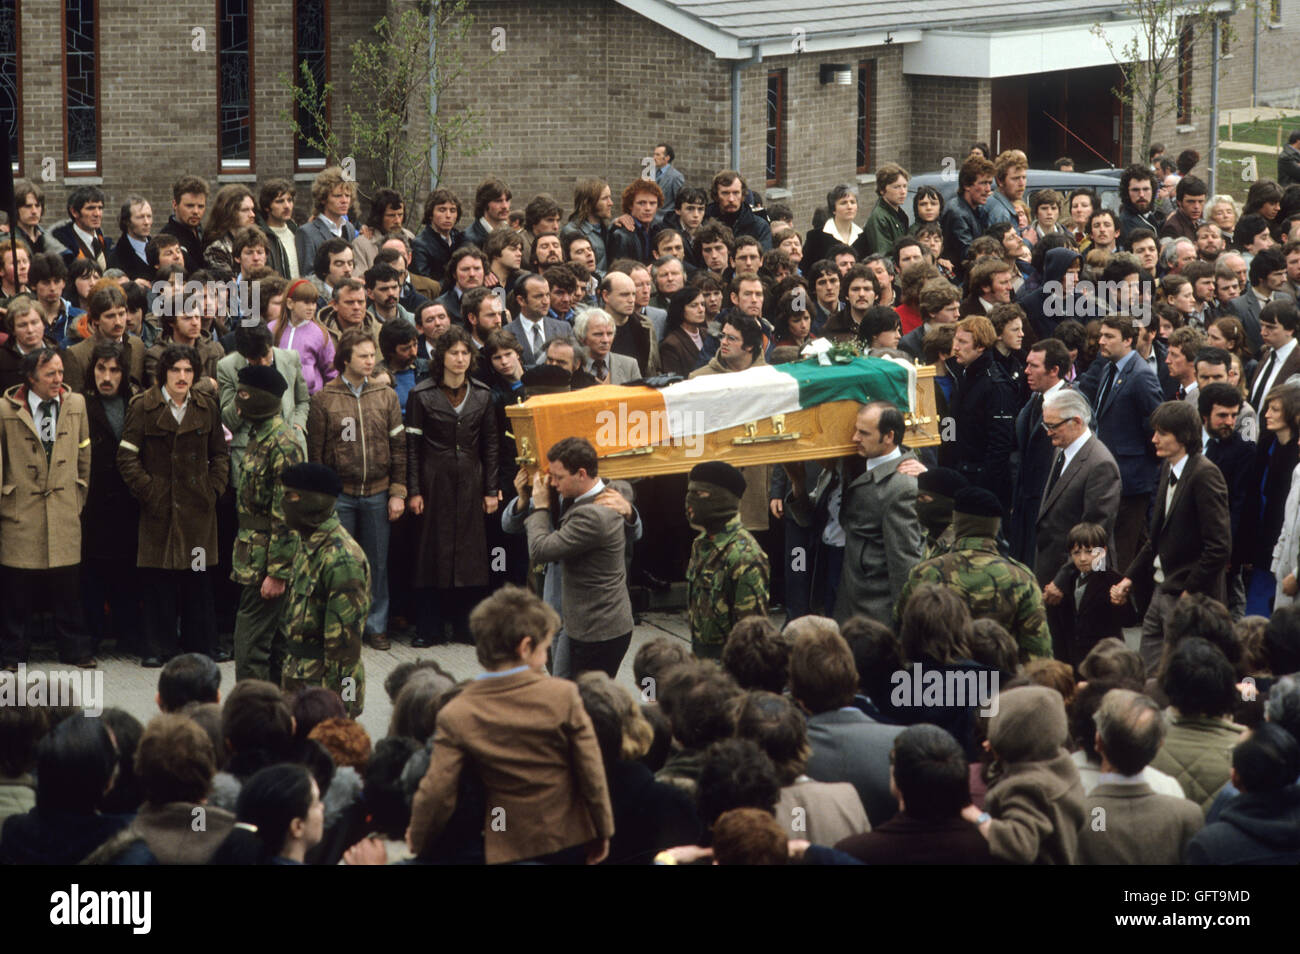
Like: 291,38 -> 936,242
281,464 -> 371,719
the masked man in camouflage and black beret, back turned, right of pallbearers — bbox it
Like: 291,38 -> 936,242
894,486 -> 1052,660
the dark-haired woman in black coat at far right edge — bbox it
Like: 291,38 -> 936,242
1238,385 -> 1300,616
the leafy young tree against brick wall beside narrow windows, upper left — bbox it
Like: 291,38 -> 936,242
281,0 -> 493,207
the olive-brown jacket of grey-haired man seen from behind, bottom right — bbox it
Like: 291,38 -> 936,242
1079,782 -> 1205,864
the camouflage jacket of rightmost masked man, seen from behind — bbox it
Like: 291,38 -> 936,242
894,537 -> 1052,658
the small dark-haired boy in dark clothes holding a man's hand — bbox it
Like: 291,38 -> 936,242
1048,524 -> 1130,667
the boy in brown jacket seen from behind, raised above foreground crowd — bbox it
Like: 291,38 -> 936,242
407,586 -> 614,864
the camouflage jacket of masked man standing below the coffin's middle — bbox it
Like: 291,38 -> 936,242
686,516 -> 768,659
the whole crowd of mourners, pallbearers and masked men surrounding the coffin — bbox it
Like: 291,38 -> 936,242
0,134 -> 1300,864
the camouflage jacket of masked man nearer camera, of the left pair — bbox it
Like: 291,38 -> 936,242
281,516 -> 371,719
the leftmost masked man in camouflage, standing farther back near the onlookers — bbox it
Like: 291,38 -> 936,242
230,364 -> 303,682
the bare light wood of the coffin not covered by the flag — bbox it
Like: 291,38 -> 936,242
506,365 -> 940,478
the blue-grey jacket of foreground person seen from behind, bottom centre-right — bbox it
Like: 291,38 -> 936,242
803,708 -> 906,828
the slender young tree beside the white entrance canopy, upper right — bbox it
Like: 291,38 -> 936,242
1092,0 -> 1231,159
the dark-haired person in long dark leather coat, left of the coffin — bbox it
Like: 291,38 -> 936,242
406,326 -> 501,647
